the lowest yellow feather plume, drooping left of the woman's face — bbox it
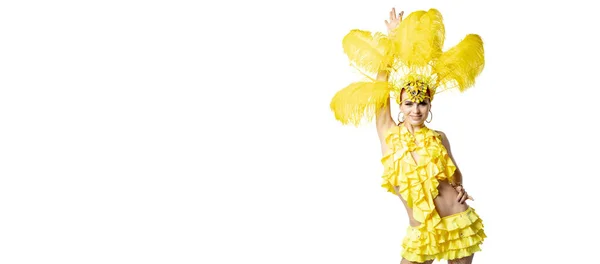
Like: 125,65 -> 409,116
330,81 -> 390,127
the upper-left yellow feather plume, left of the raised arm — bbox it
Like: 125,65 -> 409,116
342,29 -> 393,74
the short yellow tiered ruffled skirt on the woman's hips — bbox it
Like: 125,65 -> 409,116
402,207 -> 486,262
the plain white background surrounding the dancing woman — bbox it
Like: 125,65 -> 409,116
0,0 -> 600,264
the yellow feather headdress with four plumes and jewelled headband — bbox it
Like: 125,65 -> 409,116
330,8 -> 485,126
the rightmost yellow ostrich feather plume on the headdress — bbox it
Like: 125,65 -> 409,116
434,34 -> 485,92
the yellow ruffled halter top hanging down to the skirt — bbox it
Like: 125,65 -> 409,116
381,125 -> 456,230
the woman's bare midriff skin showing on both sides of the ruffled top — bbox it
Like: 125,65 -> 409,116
394,180 -> 469,226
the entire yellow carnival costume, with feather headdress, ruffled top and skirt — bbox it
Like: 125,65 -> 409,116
330,9 -> 486,262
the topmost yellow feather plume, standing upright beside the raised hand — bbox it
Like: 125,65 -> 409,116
393,8 -> 445,68
